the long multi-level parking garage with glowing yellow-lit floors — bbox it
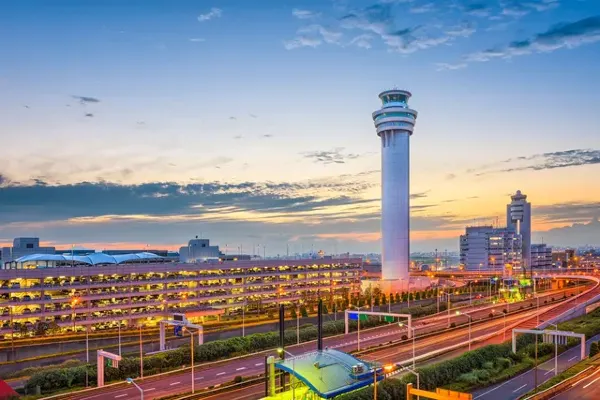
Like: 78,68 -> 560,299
0,253 -> 362,335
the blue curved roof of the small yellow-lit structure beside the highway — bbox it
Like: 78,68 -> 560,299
275,349 -> 380,399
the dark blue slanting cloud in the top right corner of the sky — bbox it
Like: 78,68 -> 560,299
464,16 -> 600,62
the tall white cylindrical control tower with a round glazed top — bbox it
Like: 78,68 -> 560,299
373,89 -> 417,286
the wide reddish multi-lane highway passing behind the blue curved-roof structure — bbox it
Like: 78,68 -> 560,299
50,288 -> 579,400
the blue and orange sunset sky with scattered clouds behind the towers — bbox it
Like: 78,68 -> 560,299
0,0 -> 600,255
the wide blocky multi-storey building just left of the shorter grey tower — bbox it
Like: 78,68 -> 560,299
460,226 -> 522,271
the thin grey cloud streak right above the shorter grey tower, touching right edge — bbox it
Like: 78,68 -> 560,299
471,149 -> 600,176
